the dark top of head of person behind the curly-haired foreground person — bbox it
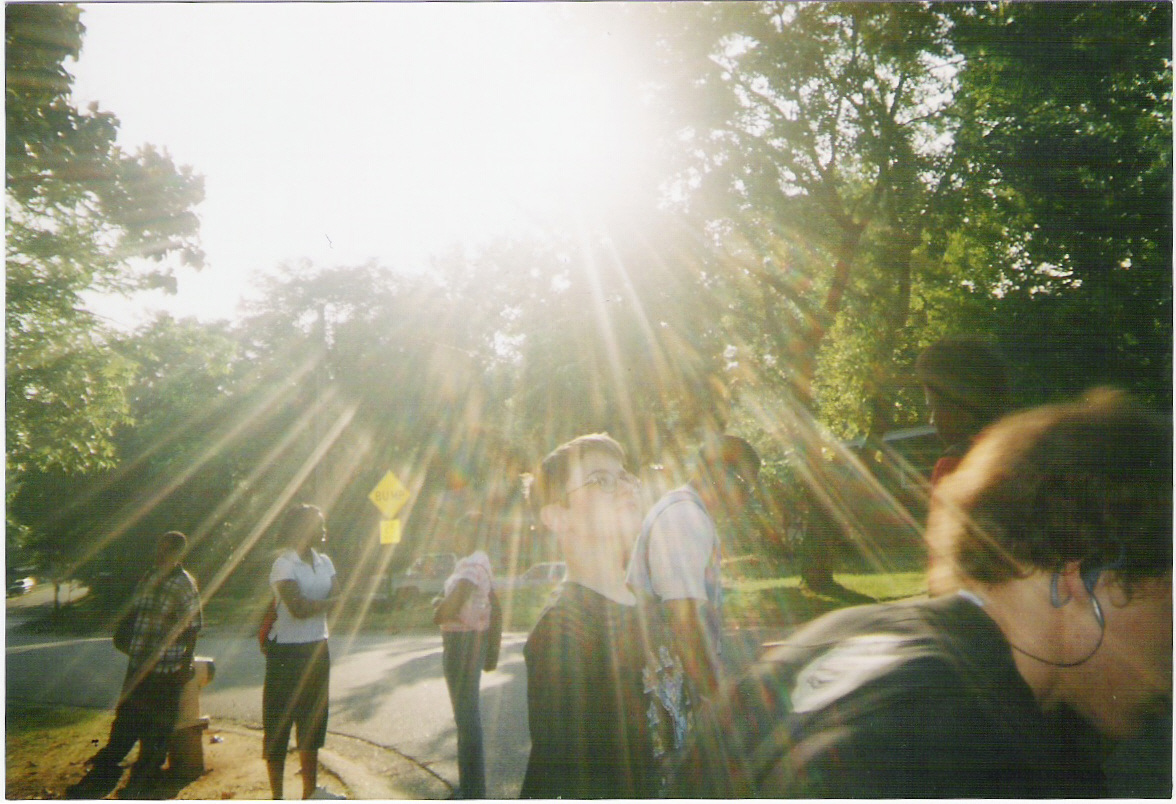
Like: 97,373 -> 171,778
915,335 -> 1011,427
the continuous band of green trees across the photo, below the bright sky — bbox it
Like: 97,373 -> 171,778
6,2 -> 1172,594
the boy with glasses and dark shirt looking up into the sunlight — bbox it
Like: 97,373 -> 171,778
520,434 -> 657,798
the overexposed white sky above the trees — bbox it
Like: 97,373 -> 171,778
66,2 -> 663,323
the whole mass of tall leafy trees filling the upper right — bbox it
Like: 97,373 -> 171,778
634,2 -> 1171,436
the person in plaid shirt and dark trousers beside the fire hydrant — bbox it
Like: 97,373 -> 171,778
91,531 -> 203,779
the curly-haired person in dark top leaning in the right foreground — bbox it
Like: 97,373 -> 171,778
670,390 -> 1172,798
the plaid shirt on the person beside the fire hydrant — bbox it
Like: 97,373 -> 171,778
127,567 -> 203,675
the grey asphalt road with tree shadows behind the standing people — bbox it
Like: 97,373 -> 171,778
5,589 -> 779,798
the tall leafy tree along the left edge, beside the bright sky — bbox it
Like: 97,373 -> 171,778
5,4 -> 203,490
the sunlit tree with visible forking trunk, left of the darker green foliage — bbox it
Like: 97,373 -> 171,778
630,2 -> 969,434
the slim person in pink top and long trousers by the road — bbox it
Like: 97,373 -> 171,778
433,511 -> 494,798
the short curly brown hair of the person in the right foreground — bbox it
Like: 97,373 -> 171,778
928,389 -> 1172,591
